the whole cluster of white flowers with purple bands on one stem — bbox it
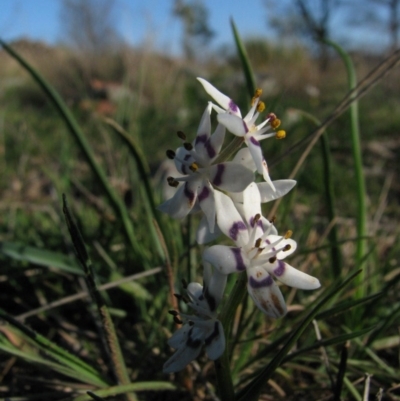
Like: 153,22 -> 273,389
159,78 -> 320,373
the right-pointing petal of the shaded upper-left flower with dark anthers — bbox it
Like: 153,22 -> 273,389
210,162 -> 254,192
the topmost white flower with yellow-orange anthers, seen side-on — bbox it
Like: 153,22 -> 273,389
197,78 -> 285,189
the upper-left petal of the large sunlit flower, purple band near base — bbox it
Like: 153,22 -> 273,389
215,191 -> 249,246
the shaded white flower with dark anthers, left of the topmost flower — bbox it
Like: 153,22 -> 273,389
159,104 -> 254,232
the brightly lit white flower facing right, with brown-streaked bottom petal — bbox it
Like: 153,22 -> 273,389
203,183 -> 320,318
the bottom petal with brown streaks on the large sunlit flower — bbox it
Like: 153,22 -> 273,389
247,267 -> 287,318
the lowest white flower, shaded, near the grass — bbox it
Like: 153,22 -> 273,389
163,264 -> 226,373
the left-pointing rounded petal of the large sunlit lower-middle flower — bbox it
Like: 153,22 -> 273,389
203,245 -> 249,275
